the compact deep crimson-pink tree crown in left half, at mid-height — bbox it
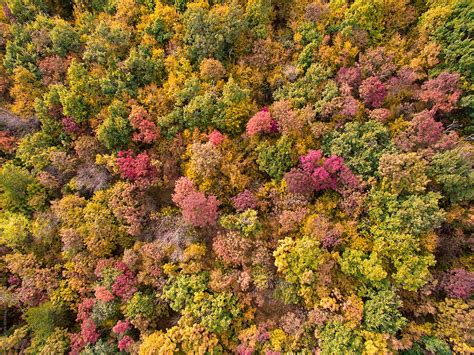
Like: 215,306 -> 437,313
116,150 -> 157,183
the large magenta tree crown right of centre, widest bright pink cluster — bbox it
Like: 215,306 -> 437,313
285,150 -> 359,195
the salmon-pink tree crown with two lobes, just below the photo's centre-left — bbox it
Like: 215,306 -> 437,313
172,177 -> 219,227
